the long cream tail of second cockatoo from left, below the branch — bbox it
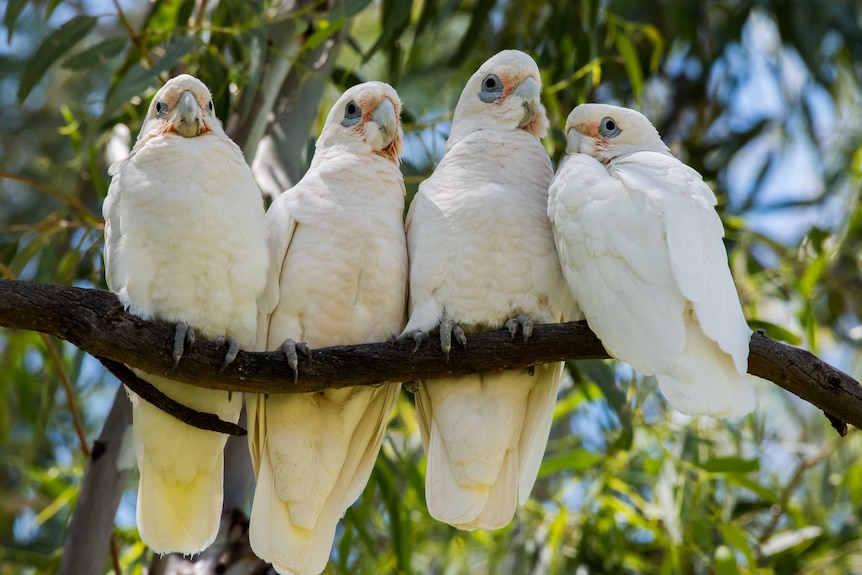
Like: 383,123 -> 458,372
248,384 -> 401,575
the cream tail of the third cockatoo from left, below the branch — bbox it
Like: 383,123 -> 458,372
416,364 -> 562,530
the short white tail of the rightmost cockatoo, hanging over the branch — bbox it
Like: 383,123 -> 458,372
656,322 -> 757,417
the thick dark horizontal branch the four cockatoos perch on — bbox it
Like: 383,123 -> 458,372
0,280 -> 862,432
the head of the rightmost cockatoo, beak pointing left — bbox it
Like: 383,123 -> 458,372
566,104 -> 670,164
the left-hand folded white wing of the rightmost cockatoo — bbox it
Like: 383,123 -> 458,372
548,154 -> 686,375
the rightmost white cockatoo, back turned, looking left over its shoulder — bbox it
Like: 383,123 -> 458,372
548,104 -> 757,417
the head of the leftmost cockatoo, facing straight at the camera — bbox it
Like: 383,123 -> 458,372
138,74 -> 222,143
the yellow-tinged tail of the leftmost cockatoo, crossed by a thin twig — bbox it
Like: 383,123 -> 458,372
129,376 -> 242,555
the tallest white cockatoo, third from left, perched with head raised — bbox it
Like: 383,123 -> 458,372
402,50 -> 572,529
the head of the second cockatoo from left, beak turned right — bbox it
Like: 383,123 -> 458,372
317,82 -> 404,164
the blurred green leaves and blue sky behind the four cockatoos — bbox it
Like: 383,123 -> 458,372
0,0 -> 862,575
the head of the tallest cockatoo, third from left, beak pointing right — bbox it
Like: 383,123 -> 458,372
446,50 -> 548,150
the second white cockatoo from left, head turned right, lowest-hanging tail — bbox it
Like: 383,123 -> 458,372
246,82 -> 407,575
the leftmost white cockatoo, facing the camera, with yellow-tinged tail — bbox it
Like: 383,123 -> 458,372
102,74 -> 269,554
